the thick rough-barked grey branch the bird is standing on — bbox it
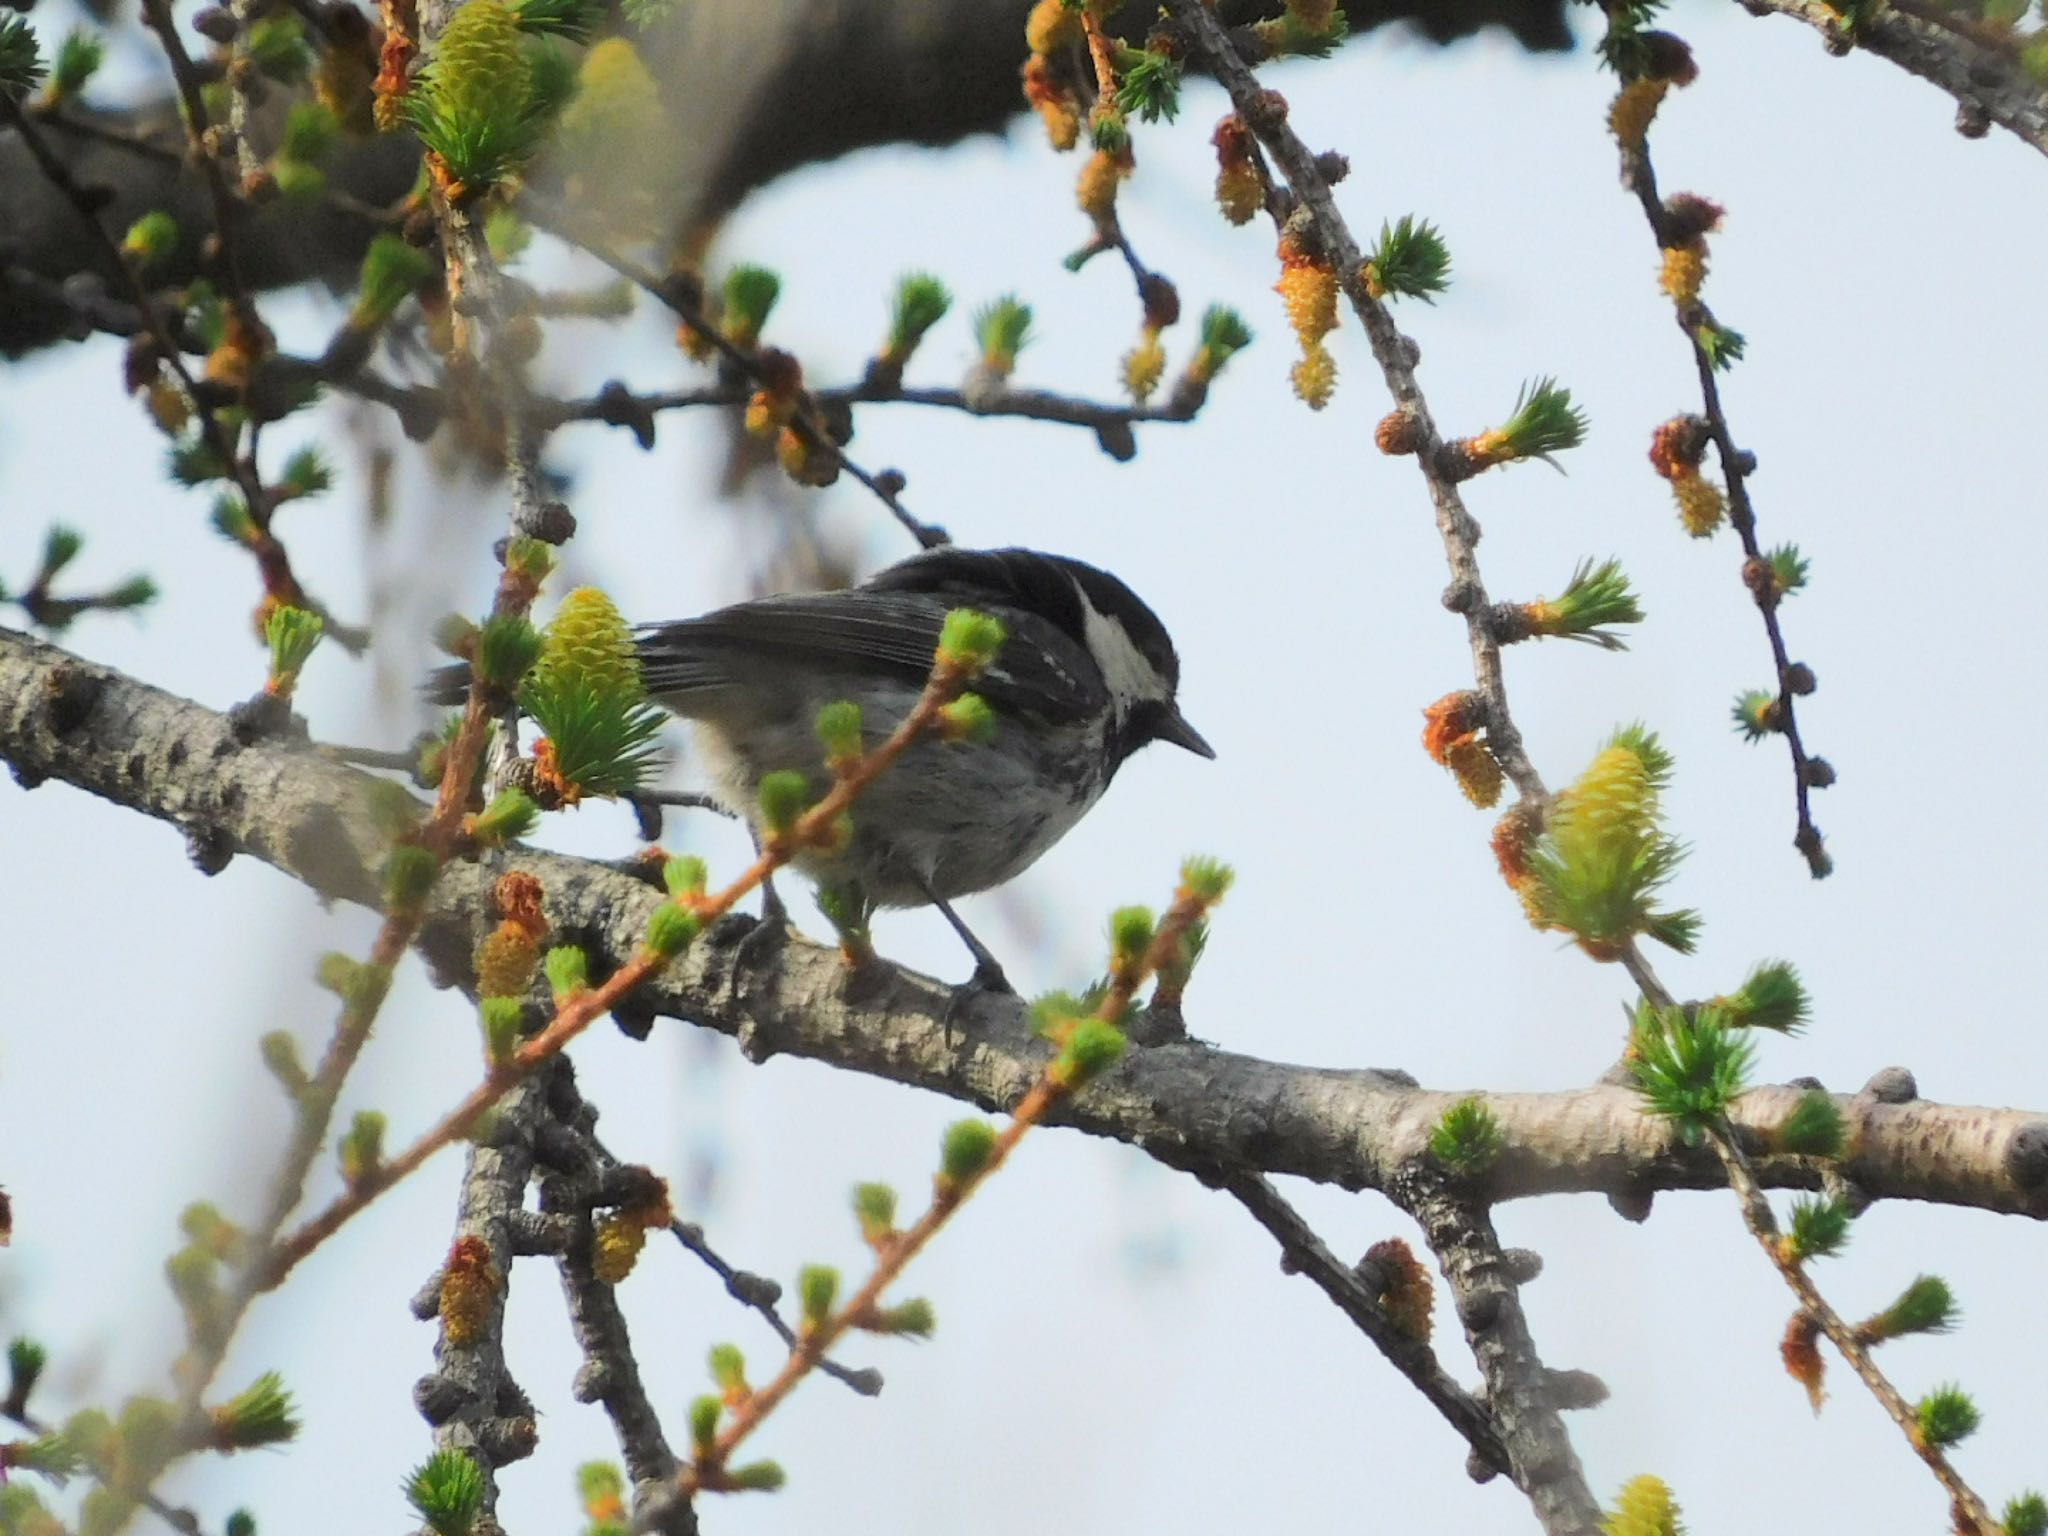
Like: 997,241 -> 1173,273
12,629 -> 2048,1217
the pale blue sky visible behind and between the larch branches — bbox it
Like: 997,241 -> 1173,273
0,6 -> 2048,1536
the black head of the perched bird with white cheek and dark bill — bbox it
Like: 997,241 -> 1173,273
872,545 -> 1217,762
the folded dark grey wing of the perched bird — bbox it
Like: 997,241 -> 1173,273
639,588 -> 1106,723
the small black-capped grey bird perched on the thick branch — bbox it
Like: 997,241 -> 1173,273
639,547 -> 1217,985
